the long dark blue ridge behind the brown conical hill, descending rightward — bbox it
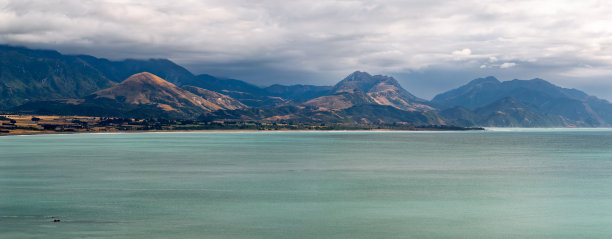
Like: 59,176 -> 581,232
0,45 -> 320,110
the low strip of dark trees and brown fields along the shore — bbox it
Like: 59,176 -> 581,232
0,115 -> 482,134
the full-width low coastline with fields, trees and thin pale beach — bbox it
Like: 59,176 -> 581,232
0,115 -> 612,136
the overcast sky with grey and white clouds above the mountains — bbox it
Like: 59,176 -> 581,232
0,0 -> 612,100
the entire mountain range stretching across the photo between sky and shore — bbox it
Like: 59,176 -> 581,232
0,46 -> 612,127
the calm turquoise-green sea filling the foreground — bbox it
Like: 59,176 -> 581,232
0,129 -> 612,238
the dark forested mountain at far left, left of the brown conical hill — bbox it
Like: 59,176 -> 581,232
0,46 -> 115,109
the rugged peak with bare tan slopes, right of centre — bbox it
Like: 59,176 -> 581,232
304,71 -> 433,111
